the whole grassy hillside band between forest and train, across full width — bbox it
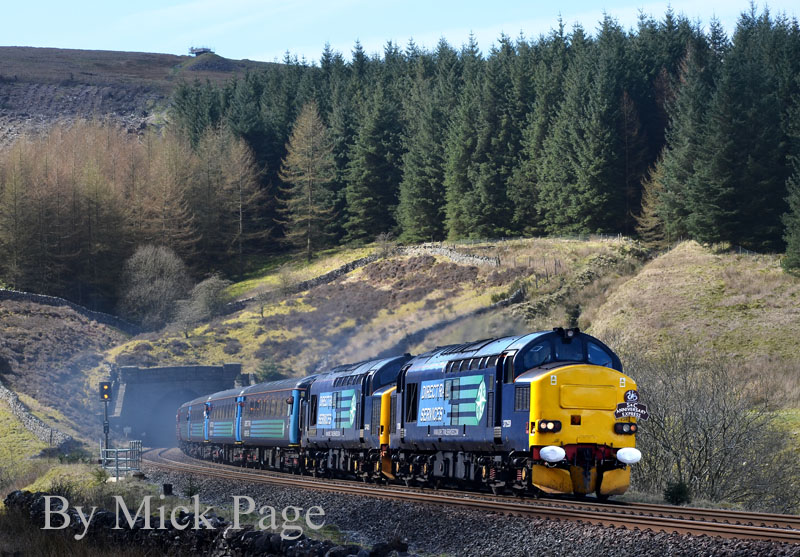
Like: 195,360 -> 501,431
6,238 -> 800,439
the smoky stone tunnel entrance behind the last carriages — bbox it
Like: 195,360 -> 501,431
109,364 -> 243,447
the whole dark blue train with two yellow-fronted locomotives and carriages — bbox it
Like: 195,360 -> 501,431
176,327 -> 649,500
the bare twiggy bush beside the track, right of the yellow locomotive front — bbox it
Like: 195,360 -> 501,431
623,346 -> 800,511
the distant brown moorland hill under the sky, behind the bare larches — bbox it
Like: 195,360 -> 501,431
0,46 -> 268,148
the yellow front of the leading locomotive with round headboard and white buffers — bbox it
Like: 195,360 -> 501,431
517,363 -> 647,498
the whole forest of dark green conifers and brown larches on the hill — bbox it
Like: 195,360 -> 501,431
0,7 -> 800,309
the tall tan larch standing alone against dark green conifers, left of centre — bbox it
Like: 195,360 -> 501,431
280,101 -> 334,261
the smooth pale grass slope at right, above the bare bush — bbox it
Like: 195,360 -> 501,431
589,242 -> 800,404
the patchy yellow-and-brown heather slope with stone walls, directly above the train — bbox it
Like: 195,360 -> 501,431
106,239 -> 638,375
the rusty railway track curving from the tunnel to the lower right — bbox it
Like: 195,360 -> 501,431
143,449 -> 800,544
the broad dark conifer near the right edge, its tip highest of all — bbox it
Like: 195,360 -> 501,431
688,12 -> 790,250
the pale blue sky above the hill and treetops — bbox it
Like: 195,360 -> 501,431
0,0 -> 800,63
